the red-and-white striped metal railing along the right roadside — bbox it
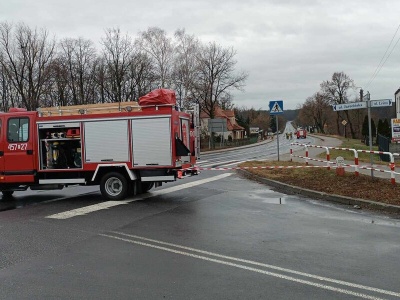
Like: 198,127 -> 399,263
290,143 -> 400,184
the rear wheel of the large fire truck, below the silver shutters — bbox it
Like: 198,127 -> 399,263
100,172 -> 128,200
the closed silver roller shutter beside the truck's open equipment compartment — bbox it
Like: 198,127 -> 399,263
84,120 -> 129,163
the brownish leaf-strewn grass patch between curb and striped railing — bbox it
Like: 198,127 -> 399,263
239,161 -> 400,205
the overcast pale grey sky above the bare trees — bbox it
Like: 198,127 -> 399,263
0,0 -> 400,109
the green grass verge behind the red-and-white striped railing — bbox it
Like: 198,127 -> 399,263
318,136 -> 388,164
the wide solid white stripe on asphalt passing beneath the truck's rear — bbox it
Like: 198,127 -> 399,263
46,173 -> 233,220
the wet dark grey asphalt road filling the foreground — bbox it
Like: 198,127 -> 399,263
0,128 -> 400,299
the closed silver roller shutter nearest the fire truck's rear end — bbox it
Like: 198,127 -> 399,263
132,118 -> 172,166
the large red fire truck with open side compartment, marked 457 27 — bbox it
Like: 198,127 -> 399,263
0,89 -> 200,200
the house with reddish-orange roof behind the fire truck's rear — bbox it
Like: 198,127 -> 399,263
200,106 -> 245,140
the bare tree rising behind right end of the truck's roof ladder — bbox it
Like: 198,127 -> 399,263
102,28 -> 133,102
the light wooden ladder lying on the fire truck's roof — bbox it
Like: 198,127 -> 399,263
37,101 -> 142,117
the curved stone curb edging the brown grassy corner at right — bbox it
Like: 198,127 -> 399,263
237,170 -> 400,213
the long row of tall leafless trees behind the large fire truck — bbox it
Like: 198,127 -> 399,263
0,22 -> 248,112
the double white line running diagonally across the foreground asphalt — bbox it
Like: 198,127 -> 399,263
99,233 -> 394,300
